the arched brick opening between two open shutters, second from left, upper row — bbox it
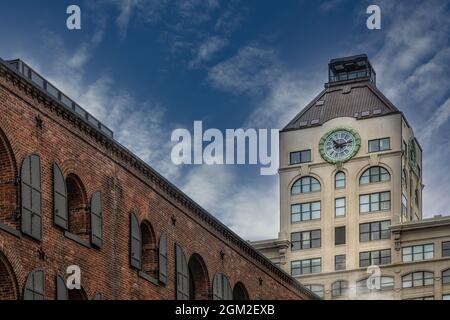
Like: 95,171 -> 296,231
66,174 -> 91,241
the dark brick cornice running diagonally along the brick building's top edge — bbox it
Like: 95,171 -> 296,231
0,59 -> 317,299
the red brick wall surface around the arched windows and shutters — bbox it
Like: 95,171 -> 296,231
0,63 -> 308,299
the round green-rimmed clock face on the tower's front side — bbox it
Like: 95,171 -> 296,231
319,127 -> 361,164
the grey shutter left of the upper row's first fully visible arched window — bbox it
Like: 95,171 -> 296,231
53,163 -> 69,230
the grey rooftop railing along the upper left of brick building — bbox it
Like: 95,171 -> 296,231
7,59 -> 114,138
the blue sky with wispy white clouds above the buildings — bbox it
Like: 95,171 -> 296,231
0,0 -> 450,240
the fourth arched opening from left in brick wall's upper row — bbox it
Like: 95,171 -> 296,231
188,253 -> 211,300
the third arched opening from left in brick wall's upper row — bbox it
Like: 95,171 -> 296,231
141,221 -> 158,279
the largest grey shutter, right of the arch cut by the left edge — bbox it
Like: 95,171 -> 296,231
21,155 -> 42,240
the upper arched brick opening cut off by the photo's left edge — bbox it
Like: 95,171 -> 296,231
0,128 -> 19,230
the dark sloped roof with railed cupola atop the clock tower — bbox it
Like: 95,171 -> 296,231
283,55 -> 400,131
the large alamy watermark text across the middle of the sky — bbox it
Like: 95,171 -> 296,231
171,121 -> 279,175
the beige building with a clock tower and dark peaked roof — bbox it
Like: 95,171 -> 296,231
253,55 -> 450,299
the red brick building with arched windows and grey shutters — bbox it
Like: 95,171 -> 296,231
0,60 -> 315,300
